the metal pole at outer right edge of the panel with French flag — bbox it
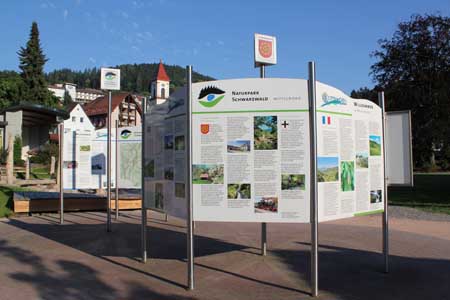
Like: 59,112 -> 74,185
378,92 -> 389,273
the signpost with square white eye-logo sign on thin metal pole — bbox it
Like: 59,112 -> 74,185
100,68 -> 120,232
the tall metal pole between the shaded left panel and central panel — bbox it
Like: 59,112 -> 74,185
186,66 -> 194,290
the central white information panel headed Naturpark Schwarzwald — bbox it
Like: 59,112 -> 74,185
191,78 -> 310,222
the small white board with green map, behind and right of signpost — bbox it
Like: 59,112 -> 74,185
117,126 -> 142,189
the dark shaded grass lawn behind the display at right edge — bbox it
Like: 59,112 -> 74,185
389,173 -> 450,214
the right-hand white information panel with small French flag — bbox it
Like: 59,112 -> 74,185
316,82 -> 384,221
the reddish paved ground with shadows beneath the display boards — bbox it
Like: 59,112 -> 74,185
0,211 -> 450,300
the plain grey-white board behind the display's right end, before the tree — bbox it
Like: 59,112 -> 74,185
386,111 -> 413,186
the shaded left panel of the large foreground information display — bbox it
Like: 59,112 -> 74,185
144,88 -> 187,219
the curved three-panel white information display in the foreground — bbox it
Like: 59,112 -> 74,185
144,78 -> 384,222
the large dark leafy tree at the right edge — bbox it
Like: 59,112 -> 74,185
371,15 -> 450,167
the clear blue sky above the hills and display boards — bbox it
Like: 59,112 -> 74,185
0,0 -> 450,93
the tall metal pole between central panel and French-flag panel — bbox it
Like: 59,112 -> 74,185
308,62 -> 319,297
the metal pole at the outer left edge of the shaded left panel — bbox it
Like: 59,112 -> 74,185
141,97 -> 147,263
